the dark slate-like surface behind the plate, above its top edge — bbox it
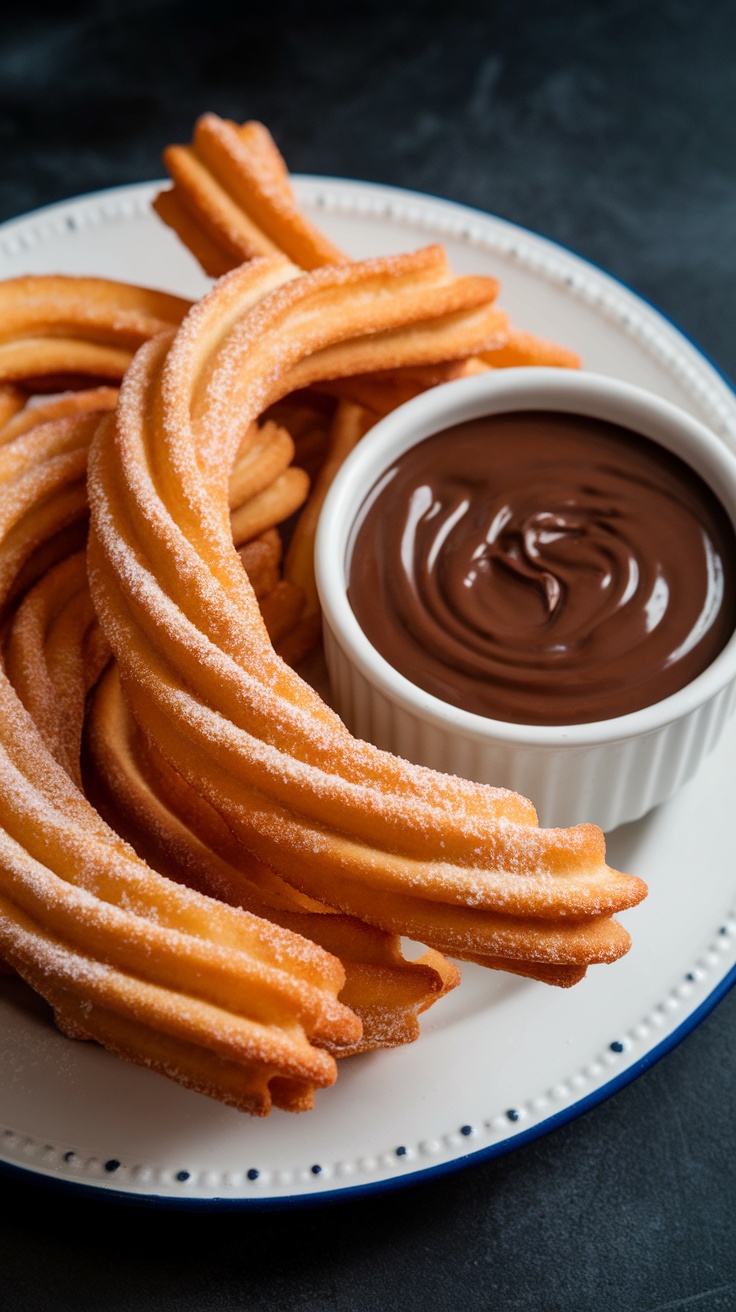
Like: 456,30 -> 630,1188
0,0 -> 736,383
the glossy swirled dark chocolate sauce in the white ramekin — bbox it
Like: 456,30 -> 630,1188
348,411 -> 736,724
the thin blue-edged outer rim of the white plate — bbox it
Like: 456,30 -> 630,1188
0,173 -> 736,1211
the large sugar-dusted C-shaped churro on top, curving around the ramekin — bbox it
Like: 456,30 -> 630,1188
89,249 -> 645,983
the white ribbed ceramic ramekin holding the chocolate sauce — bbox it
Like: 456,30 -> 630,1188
315,369 -> 736,829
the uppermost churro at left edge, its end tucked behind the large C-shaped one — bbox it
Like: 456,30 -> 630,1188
0,276 -> 190,390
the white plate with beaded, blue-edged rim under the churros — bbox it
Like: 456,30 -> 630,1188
0,178 -> 736,1207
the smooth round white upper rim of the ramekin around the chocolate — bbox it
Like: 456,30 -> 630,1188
315,366 -> 736,749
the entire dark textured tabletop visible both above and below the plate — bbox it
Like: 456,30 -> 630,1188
0,0 -> 736,1312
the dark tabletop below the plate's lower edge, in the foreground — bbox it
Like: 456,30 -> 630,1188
0,992 -> 736,1312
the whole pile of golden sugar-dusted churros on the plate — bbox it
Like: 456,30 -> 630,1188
0,114 -> 645,1115
